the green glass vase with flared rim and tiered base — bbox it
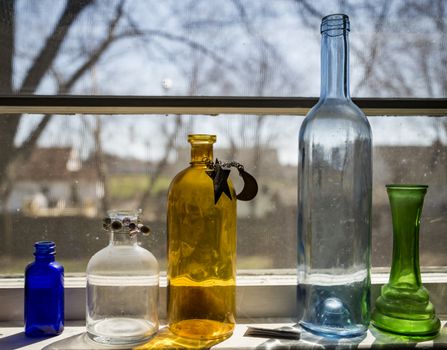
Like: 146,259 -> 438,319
372,185 -> 440,336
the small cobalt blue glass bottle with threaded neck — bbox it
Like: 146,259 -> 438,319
25,241 -> 64,337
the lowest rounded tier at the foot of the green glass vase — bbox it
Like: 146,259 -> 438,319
372,310 -> 441,336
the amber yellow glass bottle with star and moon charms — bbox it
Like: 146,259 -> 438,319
167,135 -> 236,339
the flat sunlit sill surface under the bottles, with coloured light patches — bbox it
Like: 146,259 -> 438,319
0,320 -> 447,350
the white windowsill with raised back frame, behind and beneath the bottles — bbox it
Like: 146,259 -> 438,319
0,270 -> 447,350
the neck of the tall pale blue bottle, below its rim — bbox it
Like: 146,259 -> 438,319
320,29 -> 350,100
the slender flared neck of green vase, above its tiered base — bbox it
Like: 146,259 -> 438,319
387,187 -> 427,288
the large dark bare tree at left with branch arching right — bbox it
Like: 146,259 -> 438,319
0,0 -> 245,215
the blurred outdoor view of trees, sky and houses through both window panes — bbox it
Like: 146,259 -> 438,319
0,0 -> 447,276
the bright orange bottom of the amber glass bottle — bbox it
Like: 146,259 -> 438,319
169,319 -> 234,339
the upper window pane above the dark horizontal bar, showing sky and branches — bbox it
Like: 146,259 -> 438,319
0,0 -> 447,97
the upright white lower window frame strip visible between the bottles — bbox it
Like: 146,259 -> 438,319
0,269 -> 447,322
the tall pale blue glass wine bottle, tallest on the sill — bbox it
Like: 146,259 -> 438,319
297,14 -> 372,337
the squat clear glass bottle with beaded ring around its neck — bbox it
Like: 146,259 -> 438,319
86,210 -> 159,344
